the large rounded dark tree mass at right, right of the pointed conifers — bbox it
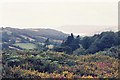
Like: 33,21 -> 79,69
87,31 -> 119,53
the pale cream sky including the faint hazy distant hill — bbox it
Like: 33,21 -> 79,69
0,0 -> 118,35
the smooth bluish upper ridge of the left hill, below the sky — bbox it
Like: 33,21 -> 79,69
3,27 -> 68,40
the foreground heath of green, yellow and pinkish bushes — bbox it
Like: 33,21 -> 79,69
3,50 -> 119,78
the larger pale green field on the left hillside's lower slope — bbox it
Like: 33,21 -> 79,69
14,43 -> 36,49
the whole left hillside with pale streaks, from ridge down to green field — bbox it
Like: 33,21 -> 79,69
1,27 -> 68,49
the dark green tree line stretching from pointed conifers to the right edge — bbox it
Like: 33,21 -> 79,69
55,31 -> 120,54
